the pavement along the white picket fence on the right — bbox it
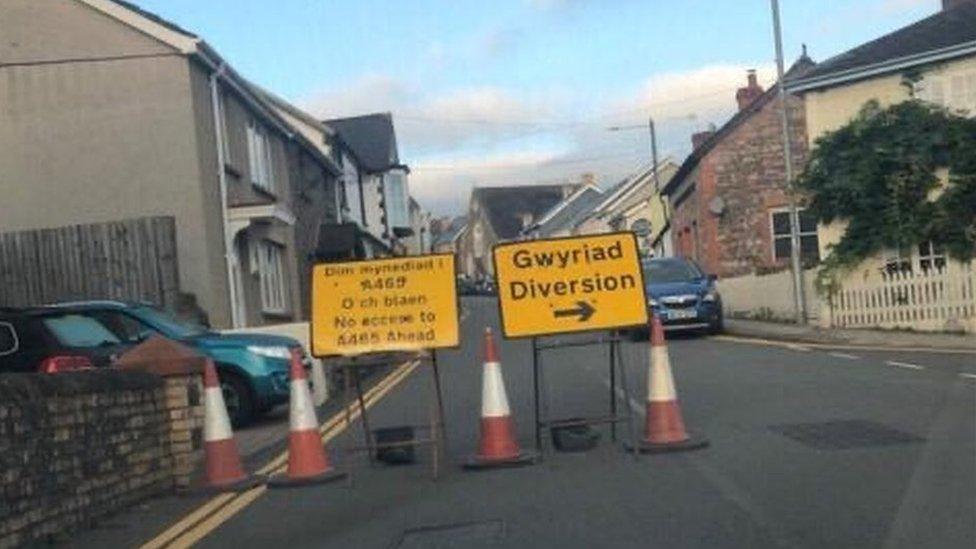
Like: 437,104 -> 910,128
725,318 -> 976,352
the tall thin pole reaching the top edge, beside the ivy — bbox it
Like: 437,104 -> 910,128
770,0 -> 807,324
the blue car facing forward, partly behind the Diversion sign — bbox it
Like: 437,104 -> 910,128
642,257 -> 723,333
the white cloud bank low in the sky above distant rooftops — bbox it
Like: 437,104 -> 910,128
300,63 -> 775,214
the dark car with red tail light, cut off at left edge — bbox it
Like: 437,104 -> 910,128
0,308 -> 133,373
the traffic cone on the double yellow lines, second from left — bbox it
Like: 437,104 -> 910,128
268,350 -> 346,488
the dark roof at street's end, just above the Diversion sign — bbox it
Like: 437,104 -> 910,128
472,185 -> 578,240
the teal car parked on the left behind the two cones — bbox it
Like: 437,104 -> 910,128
43,301 -> 311,425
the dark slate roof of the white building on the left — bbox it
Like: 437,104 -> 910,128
323,112 -> 400,173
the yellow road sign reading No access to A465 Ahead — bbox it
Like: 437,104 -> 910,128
312,254 -> 458,357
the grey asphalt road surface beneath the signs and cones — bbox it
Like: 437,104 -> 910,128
71,298 -> 976,548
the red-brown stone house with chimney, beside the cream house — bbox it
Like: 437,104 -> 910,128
664,52 -> 819,278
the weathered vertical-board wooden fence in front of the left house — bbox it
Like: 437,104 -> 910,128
0,217 -> 180,308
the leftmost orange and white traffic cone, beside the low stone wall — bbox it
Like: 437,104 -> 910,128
200,360 -> 264,491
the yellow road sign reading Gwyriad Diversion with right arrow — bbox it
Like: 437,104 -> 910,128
492,232 -> 647,337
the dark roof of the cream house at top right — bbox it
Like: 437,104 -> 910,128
787,3 -> 976,91
